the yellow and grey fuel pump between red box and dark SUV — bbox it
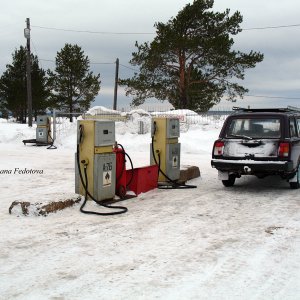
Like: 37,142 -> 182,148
150,117 -> 180,182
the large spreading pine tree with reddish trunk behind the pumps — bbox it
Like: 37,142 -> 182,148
120,0 -> 263,112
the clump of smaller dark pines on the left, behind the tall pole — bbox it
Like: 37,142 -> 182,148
0,44 -> 101,123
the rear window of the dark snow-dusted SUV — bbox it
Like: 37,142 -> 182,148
226,118 -> 281,138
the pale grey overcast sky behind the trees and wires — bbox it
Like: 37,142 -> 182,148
0,0 -> 300,107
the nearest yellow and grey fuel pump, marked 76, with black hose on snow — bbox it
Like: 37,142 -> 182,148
75,120 -> 127,215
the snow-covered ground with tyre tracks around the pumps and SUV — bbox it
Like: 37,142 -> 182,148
0,110 -> 300,300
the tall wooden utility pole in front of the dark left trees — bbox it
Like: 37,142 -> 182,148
24,18 -> 32,127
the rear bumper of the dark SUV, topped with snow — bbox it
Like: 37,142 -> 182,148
211,159 -> 294,174
